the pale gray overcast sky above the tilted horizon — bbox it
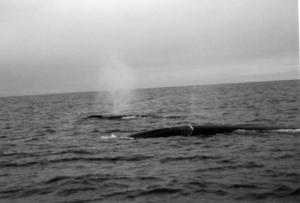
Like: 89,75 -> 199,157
0,0 -> 299,96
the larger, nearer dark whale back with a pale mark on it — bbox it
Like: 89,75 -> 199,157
129,125 -> 295,139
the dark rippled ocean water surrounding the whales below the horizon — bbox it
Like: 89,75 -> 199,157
0,80 -> 300,203
